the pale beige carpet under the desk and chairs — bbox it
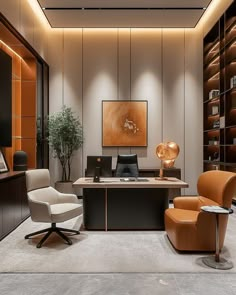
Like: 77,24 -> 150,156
0,214 -> 236,273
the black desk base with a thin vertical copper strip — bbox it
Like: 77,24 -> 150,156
83,188 -> 169,230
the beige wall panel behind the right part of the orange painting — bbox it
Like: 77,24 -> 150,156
131,29 -> 163,168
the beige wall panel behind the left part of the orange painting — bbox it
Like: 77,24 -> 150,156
83,29 -> 118,172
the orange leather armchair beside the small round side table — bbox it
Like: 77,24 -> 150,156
165,170 -> 236,251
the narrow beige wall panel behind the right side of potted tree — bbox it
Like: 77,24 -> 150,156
63,29 -> 83,180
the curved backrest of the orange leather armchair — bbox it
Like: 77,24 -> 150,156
197,170 -> 236,208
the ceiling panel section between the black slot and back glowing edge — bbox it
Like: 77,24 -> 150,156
45,10 -> 203,28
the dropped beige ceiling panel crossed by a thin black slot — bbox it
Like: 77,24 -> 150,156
37,0 -> 212,28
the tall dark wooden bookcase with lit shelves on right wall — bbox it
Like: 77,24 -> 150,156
203,1 -> 236,201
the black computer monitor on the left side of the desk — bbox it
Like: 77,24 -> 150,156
86,156 -> 112,177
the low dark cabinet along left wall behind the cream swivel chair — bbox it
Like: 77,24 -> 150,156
0,172 -> 29,239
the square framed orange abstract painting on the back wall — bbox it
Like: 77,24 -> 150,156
102,100 -> 148,147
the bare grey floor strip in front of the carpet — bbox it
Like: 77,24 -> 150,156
0,272 -> 236,295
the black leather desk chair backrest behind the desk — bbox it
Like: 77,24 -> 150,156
115,154 -> 139,177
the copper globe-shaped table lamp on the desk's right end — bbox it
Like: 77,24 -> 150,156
156,141 -> 179,179
